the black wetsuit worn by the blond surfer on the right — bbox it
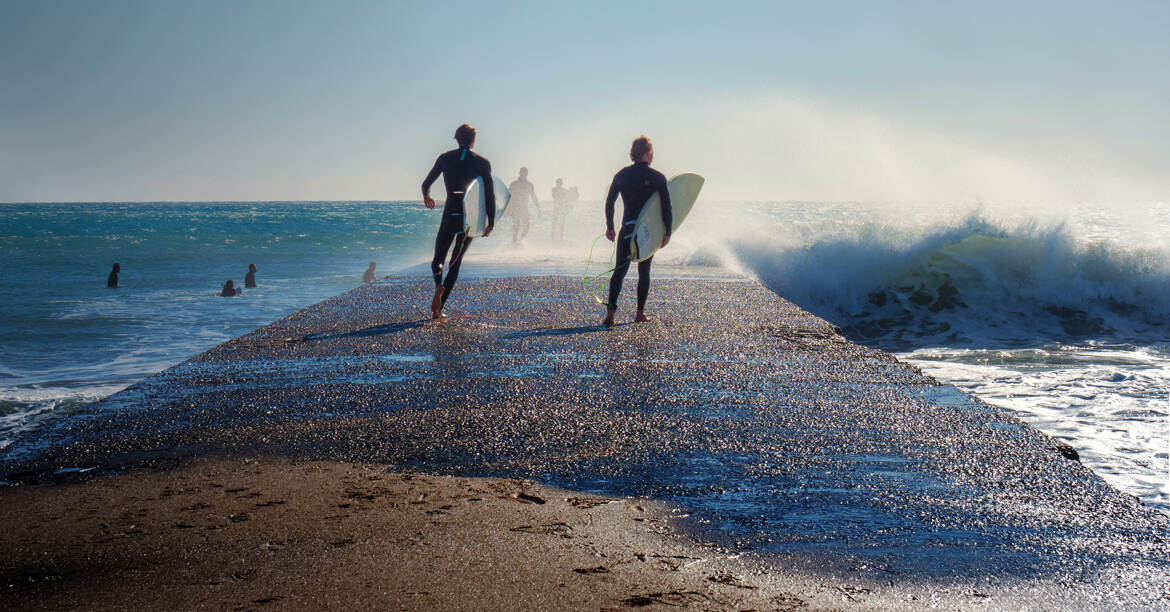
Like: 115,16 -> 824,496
605,161 -> 673,310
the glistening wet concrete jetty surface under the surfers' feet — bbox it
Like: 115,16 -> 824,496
0,277 -> 1170,607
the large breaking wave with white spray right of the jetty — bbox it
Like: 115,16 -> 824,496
731,214 -> 1170,350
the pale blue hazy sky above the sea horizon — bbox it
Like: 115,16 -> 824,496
0,0 -> 1170,205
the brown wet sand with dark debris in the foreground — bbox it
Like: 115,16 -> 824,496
0,458 -> 828,610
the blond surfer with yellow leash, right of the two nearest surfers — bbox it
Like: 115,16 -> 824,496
603,136 -> 672,325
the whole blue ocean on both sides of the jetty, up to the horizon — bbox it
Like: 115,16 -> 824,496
0,200 -> 1170,513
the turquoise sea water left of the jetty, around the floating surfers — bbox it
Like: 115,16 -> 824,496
0,202 -> 433,446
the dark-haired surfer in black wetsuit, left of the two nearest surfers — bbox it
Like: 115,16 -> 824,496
422,123 -> 496,319
